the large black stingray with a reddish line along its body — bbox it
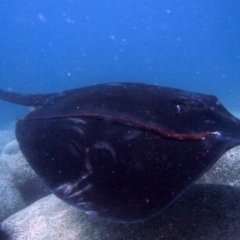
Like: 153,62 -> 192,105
0,83 -> 240,222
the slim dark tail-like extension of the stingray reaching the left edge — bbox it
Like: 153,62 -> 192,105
0,90 -> 59,106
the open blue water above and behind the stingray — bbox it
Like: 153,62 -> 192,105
0,0 -> 240,129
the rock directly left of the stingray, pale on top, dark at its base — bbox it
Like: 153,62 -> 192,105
0,140 -> 50,205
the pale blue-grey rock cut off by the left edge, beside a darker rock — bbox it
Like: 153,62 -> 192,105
0,161 -> 26,221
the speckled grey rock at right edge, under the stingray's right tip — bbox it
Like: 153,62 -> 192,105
198,146 -> 240,187
